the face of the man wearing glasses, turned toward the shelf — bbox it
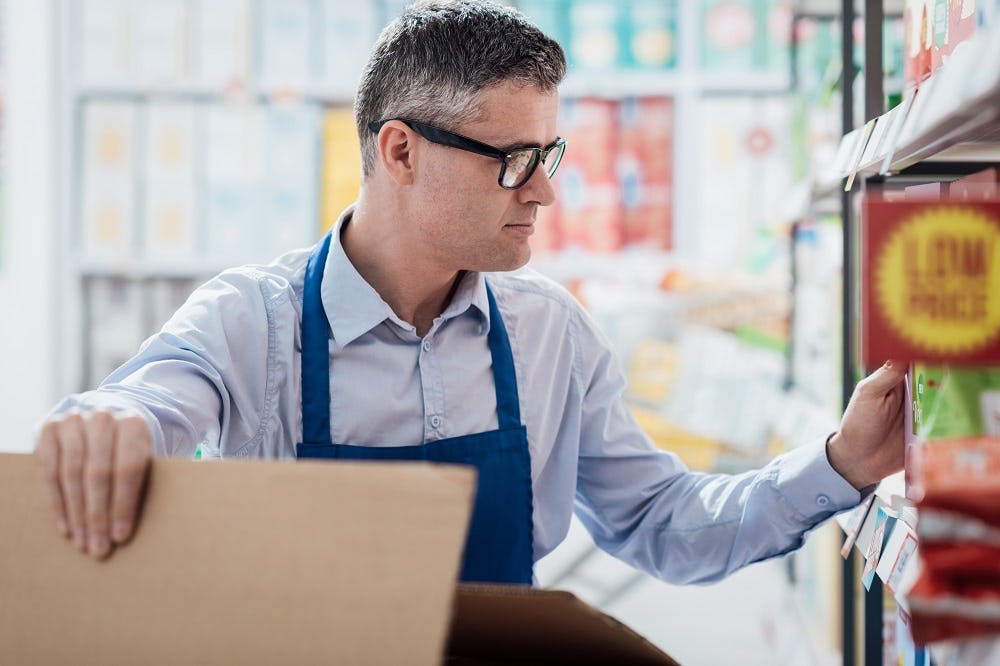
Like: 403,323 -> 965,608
415,83 -> 559,271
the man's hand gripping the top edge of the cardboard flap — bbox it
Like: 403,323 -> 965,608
35,410 -> 153,559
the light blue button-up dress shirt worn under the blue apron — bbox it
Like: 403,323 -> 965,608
55,211 -> 860,582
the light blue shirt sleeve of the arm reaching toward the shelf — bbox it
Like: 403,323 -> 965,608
576,313 -> 861,583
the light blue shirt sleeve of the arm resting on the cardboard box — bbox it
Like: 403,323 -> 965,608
52,270 -> 290,457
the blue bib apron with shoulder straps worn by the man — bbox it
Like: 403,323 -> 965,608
296,229 -> 534,585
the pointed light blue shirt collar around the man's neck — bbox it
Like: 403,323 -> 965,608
320,206 -> 490,346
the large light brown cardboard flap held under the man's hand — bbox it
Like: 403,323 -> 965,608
0,454 -> 475,665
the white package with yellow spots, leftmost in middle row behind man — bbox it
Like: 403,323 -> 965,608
80,101 -> 137,261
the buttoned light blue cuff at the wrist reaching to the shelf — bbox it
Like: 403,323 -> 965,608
776,437 -> 861,521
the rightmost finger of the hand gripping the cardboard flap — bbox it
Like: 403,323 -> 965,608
111,416 -> 152,544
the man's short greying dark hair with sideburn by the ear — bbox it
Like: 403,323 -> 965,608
354,0 -> 566,177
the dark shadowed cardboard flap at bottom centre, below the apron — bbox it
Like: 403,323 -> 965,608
445,584 -> 677,666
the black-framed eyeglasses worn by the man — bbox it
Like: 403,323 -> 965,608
368,118 -> 566,190
